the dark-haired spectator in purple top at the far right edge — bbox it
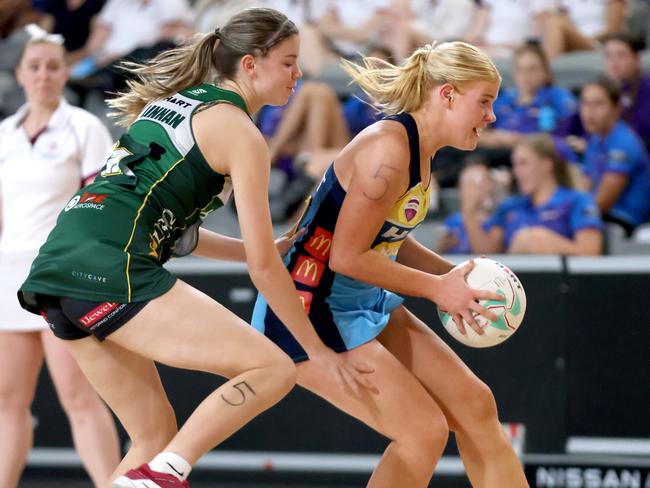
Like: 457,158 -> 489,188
603,33 -> 650,148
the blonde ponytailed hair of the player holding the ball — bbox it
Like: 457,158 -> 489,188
341,42 -> 501,114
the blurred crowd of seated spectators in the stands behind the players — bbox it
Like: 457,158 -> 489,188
0,0 -> 650,255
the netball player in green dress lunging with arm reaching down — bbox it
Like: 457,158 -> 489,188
19,9 -> 365,488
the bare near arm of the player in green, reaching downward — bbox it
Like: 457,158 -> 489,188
193,105 -> 370,390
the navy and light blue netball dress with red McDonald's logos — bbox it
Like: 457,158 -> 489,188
252,113 -> 431,361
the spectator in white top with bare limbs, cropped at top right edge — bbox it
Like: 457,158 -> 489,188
544,0 -> 627,60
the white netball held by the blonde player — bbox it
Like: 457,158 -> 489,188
438,258 -> 526,347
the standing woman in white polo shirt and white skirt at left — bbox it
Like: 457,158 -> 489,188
0,24 -> 120,488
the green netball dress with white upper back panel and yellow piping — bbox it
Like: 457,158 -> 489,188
18,84 -> 247,313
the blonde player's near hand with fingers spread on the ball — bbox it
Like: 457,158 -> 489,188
433,260 -> 503,335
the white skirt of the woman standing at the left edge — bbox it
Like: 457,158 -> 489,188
0,250 -> 48,332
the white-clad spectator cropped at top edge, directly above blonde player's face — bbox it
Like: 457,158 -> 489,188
464,0 -> 554,58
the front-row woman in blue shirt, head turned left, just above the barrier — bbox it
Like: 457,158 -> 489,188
461,134 -> 603,255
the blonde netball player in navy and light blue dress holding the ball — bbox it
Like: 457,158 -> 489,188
253,42 -> 527,488
